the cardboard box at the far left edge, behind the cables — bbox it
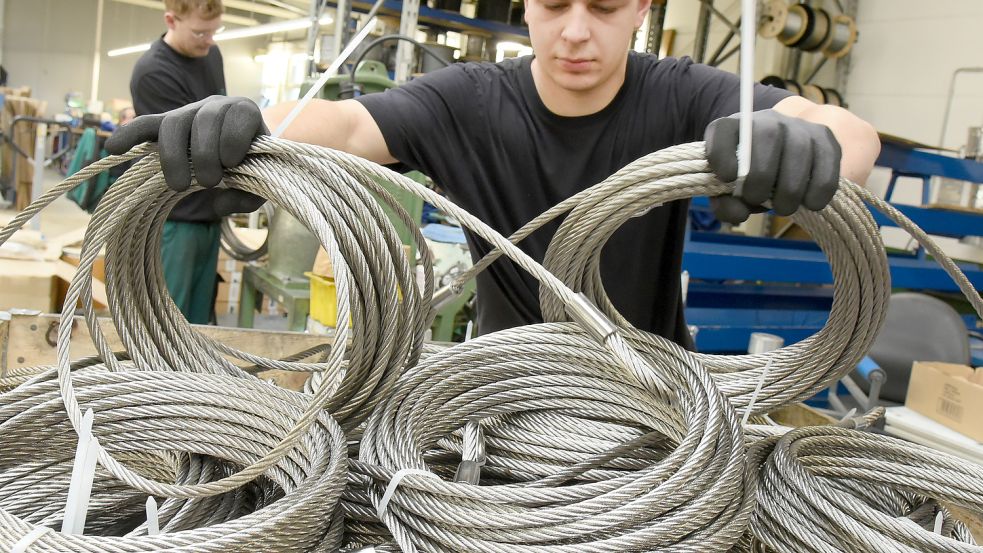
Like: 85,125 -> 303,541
0,259 -> 57,313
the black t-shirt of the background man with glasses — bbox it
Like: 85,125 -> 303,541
130,38 -> 225,222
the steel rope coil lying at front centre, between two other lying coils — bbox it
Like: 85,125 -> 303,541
352,323 -> 754,552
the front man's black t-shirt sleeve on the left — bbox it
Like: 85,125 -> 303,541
357,64 -> 483,179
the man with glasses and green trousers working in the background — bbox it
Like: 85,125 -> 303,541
130,0 -> 225,324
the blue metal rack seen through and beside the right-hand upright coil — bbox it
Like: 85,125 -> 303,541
683,143 -> 983,352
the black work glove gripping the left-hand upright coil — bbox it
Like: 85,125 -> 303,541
105,96 -> 269,215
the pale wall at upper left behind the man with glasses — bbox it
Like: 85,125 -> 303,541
0,0 -> 268,114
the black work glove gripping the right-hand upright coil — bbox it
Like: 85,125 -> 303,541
704,110 -> 841,224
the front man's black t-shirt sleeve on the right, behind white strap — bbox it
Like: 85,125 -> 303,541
670,58 -> 792,142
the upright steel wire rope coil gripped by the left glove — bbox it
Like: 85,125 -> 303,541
0,138 -> 432,498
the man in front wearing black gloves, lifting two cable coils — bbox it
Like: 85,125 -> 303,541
107,0 -> 879,346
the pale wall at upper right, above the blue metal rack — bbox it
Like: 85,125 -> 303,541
846,0 -> 983,204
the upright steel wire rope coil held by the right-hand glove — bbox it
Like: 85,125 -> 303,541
456,142 -> 983,414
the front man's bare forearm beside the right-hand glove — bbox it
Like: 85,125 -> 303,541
775,97 -> 881,184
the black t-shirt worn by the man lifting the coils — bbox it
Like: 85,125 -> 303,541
359,52 -> 789,346
